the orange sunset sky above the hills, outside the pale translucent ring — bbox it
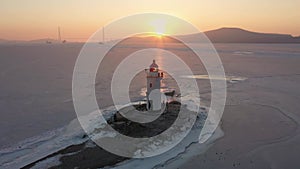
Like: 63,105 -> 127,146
0,0 -> 300,41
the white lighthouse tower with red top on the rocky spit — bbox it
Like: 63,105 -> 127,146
145,60 -> 164,111
